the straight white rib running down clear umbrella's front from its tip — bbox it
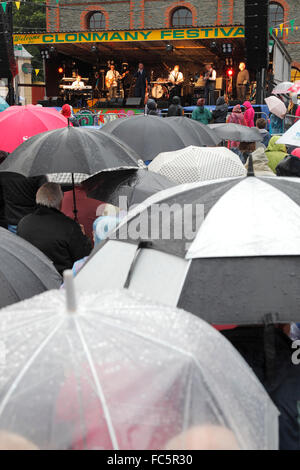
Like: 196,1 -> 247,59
74,318 -> 119,450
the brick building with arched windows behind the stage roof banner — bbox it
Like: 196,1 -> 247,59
47,0 -> 300,67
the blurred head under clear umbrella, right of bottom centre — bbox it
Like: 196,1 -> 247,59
165,424 -> 240,450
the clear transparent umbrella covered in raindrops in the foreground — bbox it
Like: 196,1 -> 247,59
0,283 -> 278,450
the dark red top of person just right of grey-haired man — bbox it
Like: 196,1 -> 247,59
61,185 -> 101,240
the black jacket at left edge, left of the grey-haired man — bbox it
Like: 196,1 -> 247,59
0,173 -> 47,225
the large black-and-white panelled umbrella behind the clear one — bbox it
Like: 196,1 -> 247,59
75,177 -> 300,325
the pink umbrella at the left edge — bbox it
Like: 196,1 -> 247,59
0,104 -> 68,152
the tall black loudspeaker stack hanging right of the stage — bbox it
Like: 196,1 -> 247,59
245,0 -> 269,71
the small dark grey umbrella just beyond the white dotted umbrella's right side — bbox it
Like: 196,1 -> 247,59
208,123 -> 262,142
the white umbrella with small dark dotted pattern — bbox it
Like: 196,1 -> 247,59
148,146 -> 246,184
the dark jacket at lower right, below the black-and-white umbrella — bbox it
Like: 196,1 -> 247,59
222,327 -> 300,450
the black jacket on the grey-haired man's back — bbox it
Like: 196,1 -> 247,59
17,206 -> 92,274
